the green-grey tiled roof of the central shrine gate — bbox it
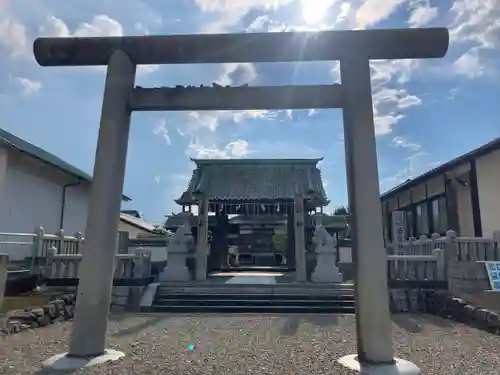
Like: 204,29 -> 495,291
176,159 -> 328,205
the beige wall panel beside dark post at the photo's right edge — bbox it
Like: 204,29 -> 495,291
476,150 -> 500,237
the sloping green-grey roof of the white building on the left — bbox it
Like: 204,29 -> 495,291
0,129 -> 131,201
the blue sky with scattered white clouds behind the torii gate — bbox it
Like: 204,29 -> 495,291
0,0 -> 500,223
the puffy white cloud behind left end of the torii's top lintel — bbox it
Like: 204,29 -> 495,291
40,14 -> 159,75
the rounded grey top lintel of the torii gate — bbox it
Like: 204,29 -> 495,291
33,28 -> 449,66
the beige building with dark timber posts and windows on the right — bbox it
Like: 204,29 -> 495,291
381,138 -> 500,242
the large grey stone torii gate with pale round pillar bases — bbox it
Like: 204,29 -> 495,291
34,28 -> 449,374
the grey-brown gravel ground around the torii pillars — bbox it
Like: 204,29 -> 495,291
0,314 -> 500,375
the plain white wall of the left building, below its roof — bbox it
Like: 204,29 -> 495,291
0,148 -> 90,234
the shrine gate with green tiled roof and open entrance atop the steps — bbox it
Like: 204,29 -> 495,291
166,159 -> 329,281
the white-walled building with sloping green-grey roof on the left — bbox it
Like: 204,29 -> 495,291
0,129 -> 130,235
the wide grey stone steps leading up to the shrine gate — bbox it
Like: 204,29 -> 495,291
141,283 -> 354,314
